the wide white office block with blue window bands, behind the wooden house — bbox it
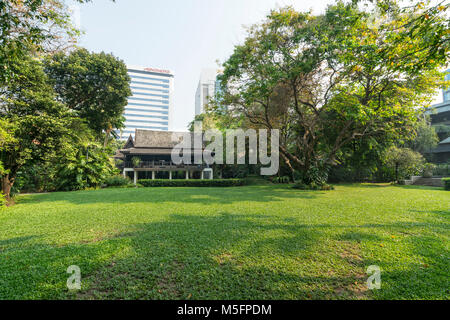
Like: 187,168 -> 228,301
119,66 -> 174,139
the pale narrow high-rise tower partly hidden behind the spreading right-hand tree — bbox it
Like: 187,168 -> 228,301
195,69 -> 219,115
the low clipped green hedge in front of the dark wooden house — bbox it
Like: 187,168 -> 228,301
139,179 -> 245,187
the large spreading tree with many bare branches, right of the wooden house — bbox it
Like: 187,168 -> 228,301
214,1 -> 449,183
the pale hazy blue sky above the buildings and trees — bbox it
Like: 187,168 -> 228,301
69,0 -> 442,131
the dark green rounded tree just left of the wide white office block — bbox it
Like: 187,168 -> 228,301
45,49 -> 131,146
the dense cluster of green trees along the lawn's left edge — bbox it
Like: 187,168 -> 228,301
0,0 -> 123,200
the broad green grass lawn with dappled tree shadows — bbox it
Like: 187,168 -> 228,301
0,185 -> 450,299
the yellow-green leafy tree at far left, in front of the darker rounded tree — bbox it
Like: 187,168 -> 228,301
0,57 -> 80,200
